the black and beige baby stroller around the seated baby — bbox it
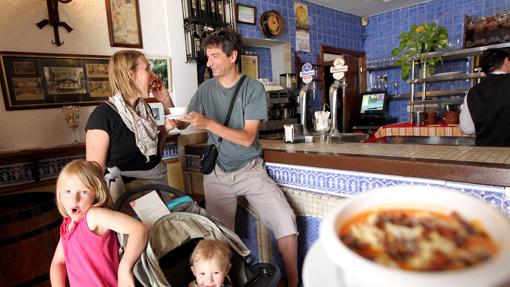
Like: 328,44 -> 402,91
114,184 -> 280,287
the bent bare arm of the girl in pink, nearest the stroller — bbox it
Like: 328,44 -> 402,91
87,207 -> 148,286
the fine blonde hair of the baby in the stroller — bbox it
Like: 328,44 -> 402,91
189,239 -> 230,269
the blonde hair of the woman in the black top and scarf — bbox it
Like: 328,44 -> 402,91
108,50 -> 144,101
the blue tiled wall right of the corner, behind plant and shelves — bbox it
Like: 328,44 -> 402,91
364,0 -> 510,121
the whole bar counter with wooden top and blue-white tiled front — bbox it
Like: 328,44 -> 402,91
183,140 -> 510,268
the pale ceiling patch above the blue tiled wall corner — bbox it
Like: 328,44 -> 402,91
308,0 -> 431,16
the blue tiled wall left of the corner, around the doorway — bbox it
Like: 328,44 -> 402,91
236,0 -> 364,110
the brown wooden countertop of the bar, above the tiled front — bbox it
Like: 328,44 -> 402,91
261,140 -> 510,187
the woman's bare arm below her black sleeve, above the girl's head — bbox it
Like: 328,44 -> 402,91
85,130 -> 110,173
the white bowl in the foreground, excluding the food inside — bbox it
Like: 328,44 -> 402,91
319,185 -> 510,287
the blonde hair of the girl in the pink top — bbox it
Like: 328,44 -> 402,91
56,160 -> 113,217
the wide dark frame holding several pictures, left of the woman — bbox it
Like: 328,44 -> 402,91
0,52 -> 112,110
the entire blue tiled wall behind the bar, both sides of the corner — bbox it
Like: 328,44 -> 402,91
237,0 -> 510,121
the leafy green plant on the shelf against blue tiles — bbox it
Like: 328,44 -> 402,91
391,23 -> 448,80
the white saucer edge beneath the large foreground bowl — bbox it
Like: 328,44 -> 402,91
303,240 -> 347,287
